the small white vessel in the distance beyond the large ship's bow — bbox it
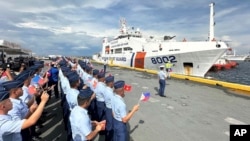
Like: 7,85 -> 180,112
221,49 -> 248,61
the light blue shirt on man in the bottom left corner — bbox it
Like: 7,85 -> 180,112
0,115 -> 25,141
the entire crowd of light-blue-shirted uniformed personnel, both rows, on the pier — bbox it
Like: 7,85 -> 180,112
0,57 -> 139,141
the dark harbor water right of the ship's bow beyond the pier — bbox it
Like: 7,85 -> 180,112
206,62 -> 250,85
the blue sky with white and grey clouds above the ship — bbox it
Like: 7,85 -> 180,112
0,0 -> 250,56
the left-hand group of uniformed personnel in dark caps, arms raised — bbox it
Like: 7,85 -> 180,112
0,61 -> 49,141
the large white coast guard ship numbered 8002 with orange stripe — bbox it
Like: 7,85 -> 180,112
93,3 -> 228,77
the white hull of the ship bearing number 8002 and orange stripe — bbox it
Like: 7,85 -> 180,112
93,42 -> 227,77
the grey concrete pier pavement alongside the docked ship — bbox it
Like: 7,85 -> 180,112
40,64 -> 250,141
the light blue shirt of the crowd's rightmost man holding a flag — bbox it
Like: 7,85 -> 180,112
111,94 -> 127,121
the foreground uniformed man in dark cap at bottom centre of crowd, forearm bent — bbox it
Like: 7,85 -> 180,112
69,87 -> 105,141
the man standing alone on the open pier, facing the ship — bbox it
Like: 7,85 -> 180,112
158,65 -> 167,97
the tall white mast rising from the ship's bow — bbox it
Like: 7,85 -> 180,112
208,2 -> 215,41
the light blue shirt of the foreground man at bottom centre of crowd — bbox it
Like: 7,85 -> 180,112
69,106 -> 92,141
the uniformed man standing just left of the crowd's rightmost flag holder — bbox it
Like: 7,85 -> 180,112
104,76 -> 114,141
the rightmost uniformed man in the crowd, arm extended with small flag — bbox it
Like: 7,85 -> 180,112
111,80 -> 139,141
